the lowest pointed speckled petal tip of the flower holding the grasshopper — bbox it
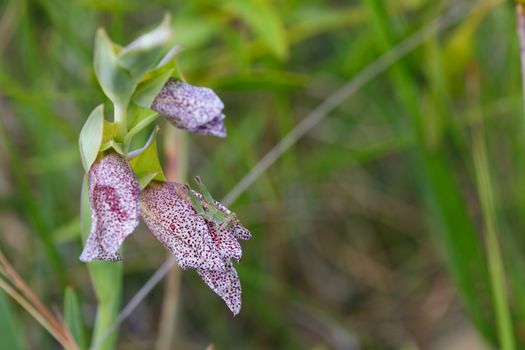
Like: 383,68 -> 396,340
197,261 -> 241,315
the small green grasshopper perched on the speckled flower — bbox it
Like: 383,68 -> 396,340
187,176 -> 239,230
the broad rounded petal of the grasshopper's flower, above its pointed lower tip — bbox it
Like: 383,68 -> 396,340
140,182 -> 224,270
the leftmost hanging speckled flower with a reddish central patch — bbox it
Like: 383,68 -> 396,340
80,153 -> 140,262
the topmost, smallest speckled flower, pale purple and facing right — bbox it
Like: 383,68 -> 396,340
151,78 -> 226,137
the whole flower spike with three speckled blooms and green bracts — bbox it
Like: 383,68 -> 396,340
79,15 -> 251,318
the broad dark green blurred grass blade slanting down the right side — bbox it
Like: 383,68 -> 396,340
365,0 -> 500,341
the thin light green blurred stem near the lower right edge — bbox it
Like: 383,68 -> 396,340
473,130 -> 516,350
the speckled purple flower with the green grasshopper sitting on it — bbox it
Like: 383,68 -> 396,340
140,182 -> 251,315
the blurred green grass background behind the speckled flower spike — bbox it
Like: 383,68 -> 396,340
0,0 -> 525,349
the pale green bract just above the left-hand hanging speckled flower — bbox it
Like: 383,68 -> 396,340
78,105 -> 104,171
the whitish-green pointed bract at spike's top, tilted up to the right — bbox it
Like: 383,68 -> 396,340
117,14 -> 173,79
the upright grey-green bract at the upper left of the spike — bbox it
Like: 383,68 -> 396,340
94,29 -> 137,106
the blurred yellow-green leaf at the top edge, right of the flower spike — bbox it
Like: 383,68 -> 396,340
225,0 -> 288,59
